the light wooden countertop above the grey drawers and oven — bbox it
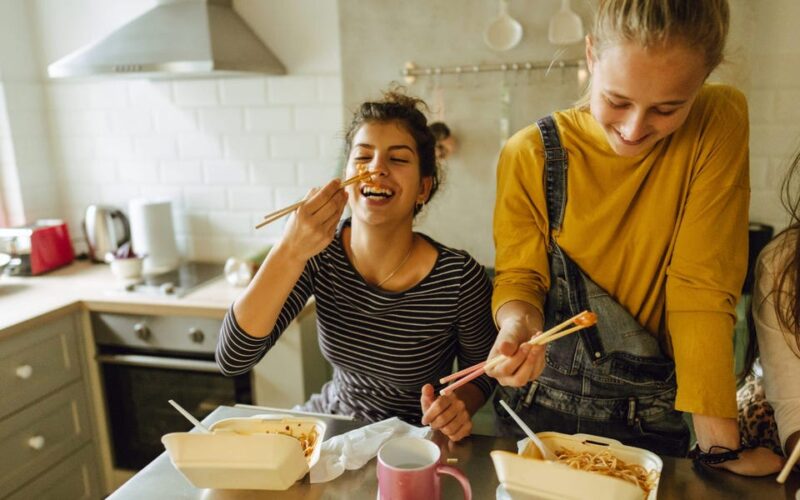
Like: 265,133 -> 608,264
0,261 -> 243,338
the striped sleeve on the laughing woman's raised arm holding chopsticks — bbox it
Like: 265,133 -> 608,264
215,259 -> 317,376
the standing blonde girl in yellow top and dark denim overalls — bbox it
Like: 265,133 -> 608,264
490,0 -> 780,475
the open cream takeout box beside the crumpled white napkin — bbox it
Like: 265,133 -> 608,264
161,415 -> 326,490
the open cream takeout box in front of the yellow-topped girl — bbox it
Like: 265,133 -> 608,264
491,432 -> 664,500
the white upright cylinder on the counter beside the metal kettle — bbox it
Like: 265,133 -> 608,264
129,199 -> 180,274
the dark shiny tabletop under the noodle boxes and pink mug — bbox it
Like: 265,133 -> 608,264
108,406 -> 800,500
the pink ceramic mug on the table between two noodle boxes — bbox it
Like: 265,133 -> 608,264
378,437 -> 472,500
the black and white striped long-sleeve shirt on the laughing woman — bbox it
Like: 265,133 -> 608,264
216,217 -> 497,424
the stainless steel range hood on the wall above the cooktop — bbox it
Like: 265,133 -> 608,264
47,0 -> 286,78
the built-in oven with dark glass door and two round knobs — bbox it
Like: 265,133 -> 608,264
91,312 -> 254,476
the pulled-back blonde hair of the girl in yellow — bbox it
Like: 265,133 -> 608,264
591,0 -> 730,73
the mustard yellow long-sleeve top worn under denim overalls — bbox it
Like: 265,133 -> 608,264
492,85 -> 750,417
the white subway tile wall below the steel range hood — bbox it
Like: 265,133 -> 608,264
49,75 -> 344,261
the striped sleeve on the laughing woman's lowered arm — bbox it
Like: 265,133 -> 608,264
457,256 -> 497,398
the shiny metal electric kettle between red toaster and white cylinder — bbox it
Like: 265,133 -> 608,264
83,205 -> 131,262
